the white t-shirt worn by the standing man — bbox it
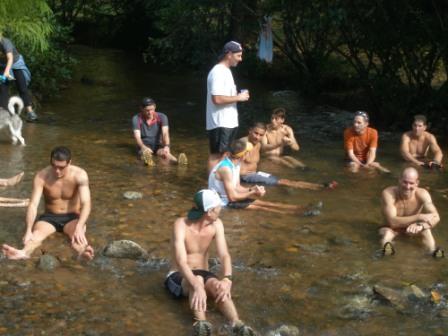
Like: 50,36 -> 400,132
206,63 -> 238,131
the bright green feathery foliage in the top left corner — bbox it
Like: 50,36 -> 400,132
0,0 -> 53,52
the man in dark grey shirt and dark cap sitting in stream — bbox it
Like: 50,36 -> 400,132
132,97 -> 187,166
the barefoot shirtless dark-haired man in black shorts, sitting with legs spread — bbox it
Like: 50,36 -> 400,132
2,147 -> 94,260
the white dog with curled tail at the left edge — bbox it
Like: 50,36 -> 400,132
0,96 -> 25,146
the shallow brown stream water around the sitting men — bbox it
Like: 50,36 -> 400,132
0,49 -> 448,335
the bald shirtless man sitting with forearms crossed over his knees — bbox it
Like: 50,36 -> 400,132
379,167 -> 444,258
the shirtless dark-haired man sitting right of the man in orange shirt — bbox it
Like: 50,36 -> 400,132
400,115 -> 443,168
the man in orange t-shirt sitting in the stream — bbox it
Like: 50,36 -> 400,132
344,111 -> 390,173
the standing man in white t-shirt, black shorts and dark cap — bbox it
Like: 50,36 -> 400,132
206,41 -> 249,170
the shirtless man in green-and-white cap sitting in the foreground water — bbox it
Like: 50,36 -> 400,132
165,189 -> 255,336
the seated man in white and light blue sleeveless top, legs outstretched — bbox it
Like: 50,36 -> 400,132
208,139 -> 322,216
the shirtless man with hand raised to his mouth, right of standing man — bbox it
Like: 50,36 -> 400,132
261,107 -> 306,169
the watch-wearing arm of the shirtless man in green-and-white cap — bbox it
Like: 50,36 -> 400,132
215,219 -> 233,303
